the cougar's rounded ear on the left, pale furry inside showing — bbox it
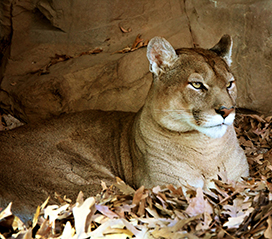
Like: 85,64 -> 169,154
146,37 -> 178,75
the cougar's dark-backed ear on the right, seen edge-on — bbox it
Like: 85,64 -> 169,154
210,35 -> 232,66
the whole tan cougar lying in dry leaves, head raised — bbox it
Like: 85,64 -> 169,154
0,35 -> 248,219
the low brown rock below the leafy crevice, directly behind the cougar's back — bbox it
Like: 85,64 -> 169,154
2,50 -> 152,122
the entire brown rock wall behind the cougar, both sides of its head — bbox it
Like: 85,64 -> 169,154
0,0 -> 272,122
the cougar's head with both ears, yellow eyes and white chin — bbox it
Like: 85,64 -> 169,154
147,35 -> 237,138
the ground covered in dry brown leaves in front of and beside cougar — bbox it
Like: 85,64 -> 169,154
0,115 -> 272,239
